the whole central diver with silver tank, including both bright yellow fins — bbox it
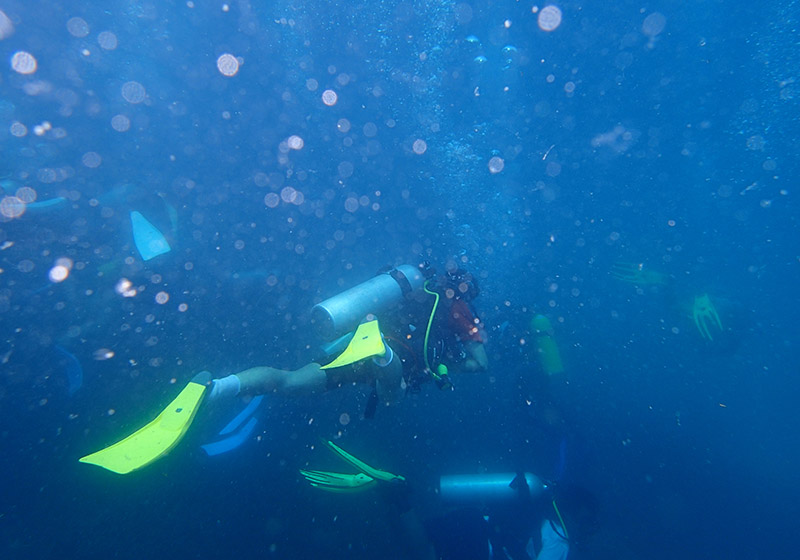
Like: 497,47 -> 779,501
80,263 -> 488,474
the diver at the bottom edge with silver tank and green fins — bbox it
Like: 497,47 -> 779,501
300,441 -> 598,560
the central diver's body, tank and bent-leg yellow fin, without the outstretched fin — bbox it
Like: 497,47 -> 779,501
210,263 -> 489,404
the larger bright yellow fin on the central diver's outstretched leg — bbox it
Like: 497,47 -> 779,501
79,372 -> 211,474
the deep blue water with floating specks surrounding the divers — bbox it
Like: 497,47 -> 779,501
0,0 -> 800,559
